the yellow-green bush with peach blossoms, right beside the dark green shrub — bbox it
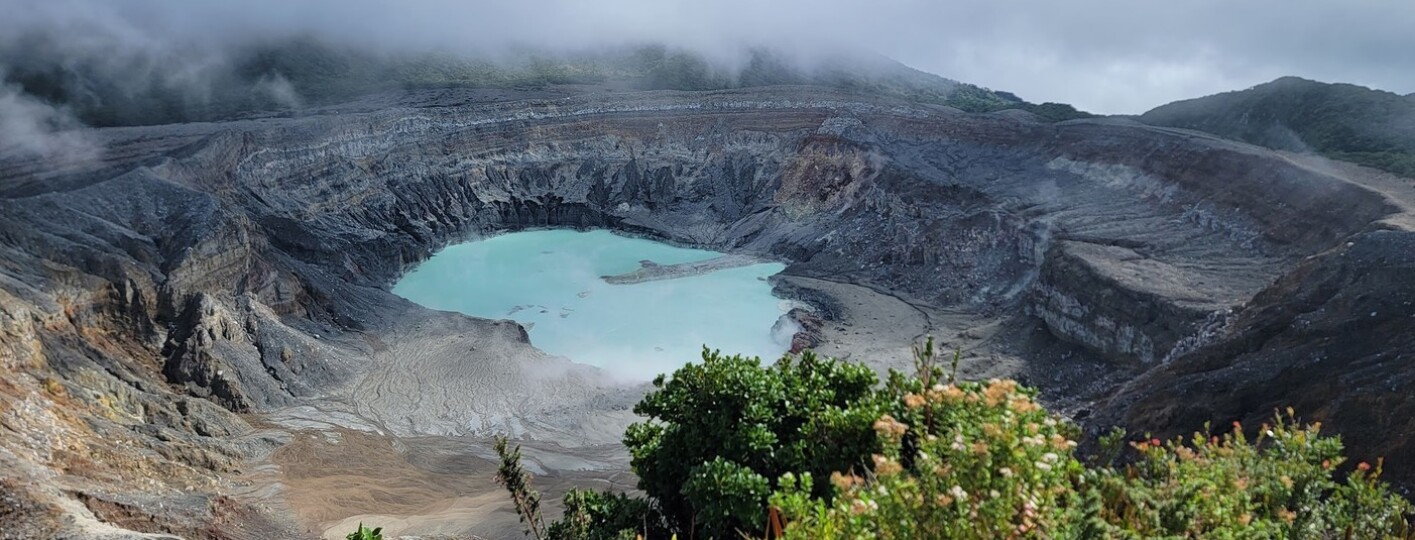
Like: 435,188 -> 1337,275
771,380 -> 1084,539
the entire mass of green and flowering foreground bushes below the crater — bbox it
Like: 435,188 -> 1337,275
497,344 -> 1415,540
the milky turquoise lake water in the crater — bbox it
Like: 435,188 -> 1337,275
393,230 -> 790,380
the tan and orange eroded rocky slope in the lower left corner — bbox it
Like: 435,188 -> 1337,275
0,267 -> 293,539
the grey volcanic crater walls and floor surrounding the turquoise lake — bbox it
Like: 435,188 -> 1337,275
0,86 -> 1415,537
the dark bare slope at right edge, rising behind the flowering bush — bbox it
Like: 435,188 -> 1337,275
1101,230 -> 1415,482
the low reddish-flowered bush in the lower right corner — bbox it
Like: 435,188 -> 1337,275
1094,410 -> 1412,539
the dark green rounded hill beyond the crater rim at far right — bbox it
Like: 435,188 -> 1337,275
1140,76 -> 1415,178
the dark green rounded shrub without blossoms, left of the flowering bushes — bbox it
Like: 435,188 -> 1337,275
624,351 -> 887,539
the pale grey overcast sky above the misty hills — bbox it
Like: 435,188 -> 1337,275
8,0 -> 1415,113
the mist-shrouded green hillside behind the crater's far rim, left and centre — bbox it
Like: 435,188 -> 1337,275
0,37 -> 1090,126
